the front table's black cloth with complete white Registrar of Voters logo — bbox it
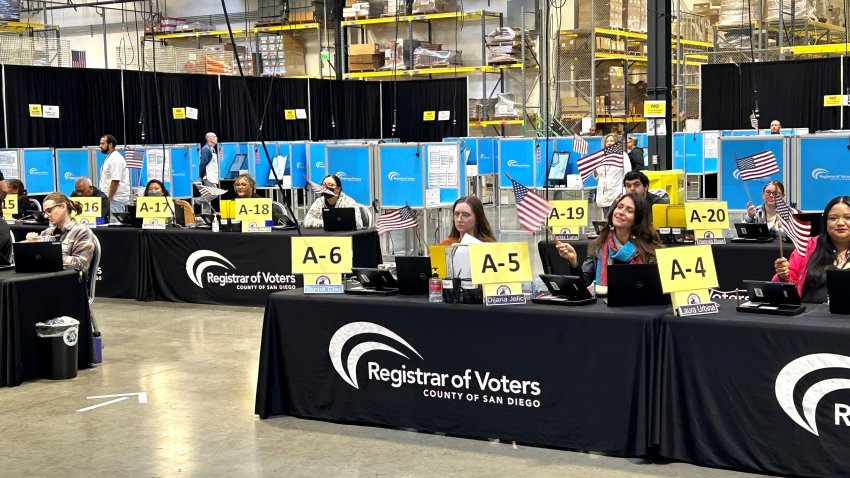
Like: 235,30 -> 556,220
255,291 -> 665,456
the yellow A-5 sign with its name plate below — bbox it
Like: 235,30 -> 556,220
469,242 -> 531,305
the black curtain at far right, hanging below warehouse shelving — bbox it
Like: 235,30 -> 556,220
700,58 -> 850,132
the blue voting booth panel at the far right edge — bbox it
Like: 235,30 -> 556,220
791,134 -> 850,212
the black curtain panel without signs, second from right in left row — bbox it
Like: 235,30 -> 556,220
309,80 -> 380,141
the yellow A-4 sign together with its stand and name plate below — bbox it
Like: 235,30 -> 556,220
655,245 -> 718,317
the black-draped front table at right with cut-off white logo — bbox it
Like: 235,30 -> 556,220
657,301 -> 850,477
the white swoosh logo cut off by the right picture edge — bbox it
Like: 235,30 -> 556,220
775,353 -> 850,436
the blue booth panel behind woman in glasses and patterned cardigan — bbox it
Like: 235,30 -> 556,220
319,144 -> 374,204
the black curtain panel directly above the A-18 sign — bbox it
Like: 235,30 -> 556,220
218,76 -> 310,141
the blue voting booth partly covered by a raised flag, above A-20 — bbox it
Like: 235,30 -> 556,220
718,135 -> 792,211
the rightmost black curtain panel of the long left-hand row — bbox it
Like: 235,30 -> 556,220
381,78 -> 468,142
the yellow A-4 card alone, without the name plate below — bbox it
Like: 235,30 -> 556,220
655,246 -> 717,293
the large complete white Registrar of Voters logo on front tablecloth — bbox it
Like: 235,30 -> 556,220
328,322 -> 543,408
